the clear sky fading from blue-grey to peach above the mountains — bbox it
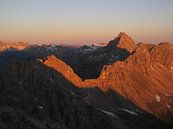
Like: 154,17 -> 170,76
0,0 -> 173,44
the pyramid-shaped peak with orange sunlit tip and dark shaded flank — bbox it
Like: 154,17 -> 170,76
73,32 -> 135,80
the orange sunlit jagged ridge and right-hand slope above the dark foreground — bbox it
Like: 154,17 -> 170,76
42,43 -> 173,122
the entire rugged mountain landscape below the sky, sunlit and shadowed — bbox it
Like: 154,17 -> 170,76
0,32 -> 173,129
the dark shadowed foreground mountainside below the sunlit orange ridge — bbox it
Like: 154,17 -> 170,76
0,56 -> 172,129
